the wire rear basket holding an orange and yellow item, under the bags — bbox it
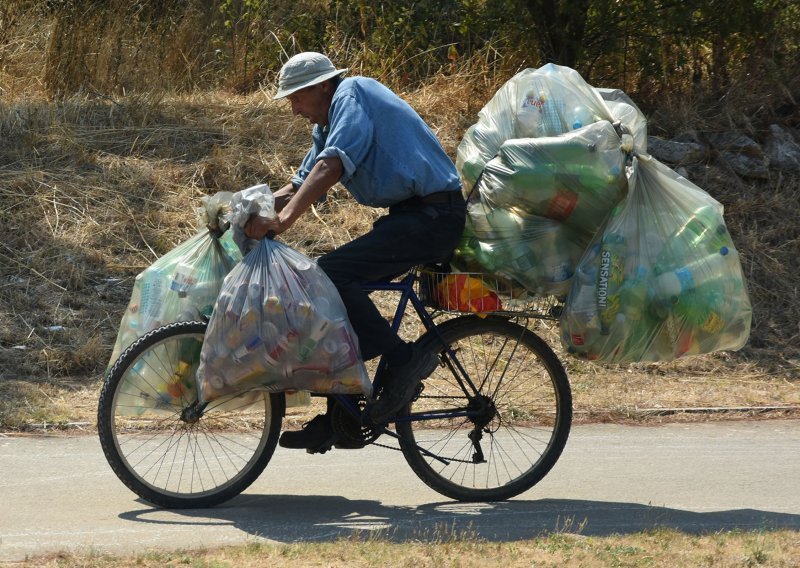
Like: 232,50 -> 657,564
417,269 -> 563,320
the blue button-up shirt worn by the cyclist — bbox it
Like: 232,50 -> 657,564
292,77 -> 461,207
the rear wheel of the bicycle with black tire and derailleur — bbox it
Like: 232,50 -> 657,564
395,316 -> 572,501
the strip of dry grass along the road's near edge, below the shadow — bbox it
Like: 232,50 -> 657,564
10,529 -> 800,568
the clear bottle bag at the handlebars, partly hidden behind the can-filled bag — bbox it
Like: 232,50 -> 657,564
109,192 -> 242,368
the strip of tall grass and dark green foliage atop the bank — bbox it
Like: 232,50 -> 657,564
0,0 -> 800,104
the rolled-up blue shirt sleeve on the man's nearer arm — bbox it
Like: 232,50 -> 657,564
318,94 -> 375,183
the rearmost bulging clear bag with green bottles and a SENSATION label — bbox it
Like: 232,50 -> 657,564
560,156 -> 752,363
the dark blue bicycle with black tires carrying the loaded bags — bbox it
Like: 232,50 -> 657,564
98,268 -> 572,508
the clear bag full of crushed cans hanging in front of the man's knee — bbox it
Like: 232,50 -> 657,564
197,186 -> 371,402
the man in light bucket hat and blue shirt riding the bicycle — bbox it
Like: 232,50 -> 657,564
245,52 -> 466,451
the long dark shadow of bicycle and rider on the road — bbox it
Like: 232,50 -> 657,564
120,495 -> 800,542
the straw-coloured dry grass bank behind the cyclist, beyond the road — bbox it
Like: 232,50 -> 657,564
0,13 -> 800,429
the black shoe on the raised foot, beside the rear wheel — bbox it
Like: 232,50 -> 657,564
367,343 -> 439,424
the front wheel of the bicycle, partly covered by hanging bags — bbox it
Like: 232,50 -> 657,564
97,322 -> 285,509
